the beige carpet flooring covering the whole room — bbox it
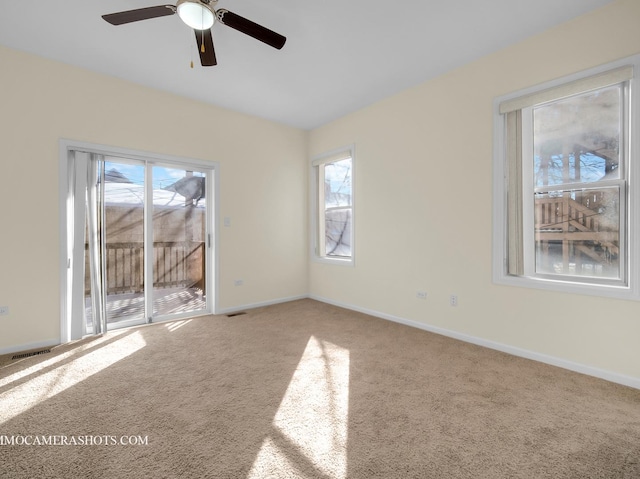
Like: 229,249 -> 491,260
0,299 -> 640,479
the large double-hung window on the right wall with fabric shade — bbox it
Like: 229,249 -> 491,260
494,57 -> 640,296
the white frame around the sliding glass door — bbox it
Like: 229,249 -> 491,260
58,139 -> 220,343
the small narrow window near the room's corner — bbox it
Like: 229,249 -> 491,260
311,147 -> 354,264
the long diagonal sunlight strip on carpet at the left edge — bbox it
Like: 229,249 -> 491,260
0,331 -> 146,424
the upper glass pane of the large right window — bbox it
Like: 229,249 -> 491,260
533,86 -> 622,187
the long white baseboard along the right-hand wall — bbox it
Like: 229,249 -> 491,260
308,295 -> 640,389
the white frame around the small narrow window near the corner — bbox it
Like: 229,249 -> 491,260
309,145 -> 356,266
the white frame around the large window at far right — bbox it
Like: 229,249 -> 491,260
492,55 -> 640,300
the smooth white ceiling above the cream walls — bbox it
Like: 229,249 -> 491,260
0,0 -> 612,129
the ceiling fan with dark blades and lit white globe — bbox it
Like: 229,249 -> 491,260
102,0 -> 287,67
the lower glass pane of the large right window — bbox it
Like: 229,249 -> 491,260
534,187 -> 621,279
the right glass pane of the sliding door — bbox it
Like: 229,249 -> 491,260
153,166 -> 206,316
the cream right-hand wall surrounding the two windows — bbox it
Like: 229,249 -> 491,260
309,0 -> 640,385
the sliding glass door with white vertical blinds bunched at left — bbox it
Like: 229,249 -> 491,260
67,144 -> 214,337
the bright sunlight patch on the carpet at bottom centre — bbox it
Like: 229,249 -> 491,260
248,336 -> 349,479
